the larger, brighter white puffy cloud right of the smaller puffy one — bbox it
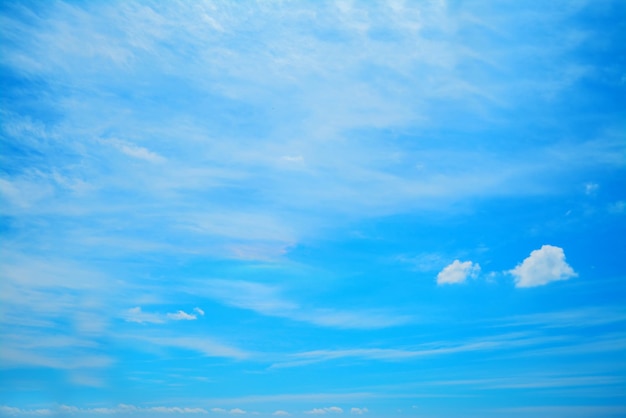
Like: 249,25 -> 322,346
509,245 -> 578,287
